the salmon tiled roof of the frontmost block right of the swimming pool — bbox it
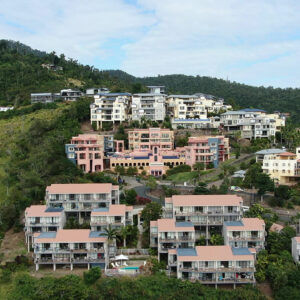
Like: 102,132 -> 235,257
177,246 -> 254,261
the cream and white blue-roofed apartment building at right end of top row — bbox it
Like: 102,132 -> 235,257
221,108 -> 284,139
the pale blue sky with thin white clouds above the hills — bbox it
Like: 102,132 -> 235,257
0,0 -> 300,88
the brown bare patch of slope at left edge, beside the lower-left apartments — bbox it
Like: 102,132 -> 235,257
0,229 -> 28,264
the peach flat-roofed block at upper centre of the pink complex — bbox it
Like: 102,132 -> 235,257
128,128 -> 174,151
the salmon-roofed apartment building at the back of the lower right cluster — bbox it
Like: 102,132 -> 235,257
164,195 -> 243,241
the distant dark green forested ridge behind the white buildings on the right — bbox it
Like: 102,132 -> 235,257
108,70 -> 300,122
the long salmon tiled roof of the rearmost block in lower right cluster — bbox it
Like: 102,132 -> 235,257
172,195 -> 243,206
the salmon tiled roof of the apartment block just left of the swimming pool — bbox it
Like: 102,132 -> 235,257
35,229 -> 107,243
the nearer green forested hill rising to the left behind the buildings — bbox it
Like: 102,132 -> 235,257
0,40 -> 139,106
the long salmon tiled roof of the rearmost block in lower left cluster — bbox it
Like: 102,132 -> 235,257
46,183 -> 116,194
